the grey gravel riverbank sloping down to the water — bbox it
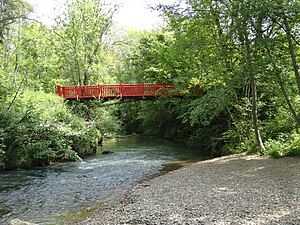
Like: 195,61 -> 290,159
82,155 -> 300,225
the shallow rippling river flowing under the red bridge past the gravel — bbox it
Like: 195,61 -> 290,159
0,137 -> 203,224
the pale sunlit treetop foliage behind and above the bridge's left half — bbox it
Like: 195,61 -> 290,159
0,0 -> 116,93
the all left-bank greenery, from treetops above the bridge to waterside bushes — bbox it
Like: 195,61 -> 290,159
0,0 -> 121,168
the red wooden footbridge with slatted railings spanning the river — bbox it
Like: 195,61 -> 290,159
57,84 -> 182,101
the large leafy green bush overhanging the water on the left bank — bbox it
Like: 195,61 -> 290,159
0,91 -> 101,168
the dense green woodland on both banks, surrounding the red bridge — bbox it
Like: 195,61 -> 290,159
0,0 -> 300,169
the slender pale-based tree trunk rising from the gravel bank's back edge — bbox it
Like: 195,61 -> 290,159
245,34 -> 265,155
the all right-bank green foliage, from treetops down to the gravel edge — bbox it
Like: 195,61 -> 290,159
119,0 -> 300,157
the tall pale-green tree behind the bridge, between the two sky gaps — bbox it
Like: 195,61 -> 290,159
55,0 -> 116,85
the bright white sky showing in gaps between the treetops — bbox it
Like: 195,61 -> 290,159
27,0 -> 176,30
